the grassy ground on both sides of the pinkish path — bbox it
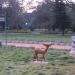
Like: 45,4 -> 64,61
0,33 -> 75,75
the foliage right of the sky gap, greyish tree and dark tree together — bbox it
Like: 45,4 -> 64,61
33,0 -> 71,34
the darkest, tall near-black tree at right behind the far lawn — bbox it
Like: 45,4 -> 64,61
55,0 -> 70,35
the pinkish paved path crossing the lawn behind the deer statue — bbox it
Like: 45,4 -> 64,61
2,42 -> 71,50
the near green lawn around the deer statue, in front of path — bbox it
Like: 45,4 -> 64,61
0,47 -> 75,75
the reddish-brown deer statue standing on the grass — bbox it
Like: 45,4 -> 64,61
34,43 -> 53,61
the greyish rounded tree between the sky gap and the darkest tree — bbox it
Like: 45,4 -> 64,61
33,0 -> 54,30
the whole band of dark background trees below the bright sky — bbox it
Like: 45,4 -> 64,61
0,0 -> 75,34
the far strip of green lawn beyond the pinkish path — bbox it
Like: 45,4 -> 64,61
0,33 -> 72,43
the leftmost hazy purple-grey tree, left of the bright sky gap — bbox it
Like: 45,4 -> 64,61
0,0 -> 22,28
